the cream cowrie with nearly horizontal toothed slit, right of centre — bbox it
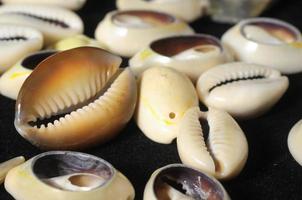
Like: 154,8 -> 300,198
196,62 -> 289,118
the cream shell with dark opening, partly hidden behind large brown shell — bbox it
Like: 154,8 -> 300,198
0,51 -> 55,100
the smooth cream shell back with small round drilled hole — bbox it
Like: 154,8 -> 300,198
135,67 -> 198,144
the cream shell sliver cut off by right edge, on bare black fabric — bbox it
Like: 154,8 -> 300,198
287,120 -> 302,166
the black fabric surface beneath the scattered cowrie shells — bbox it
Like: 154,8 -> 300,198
0,0 -> 302,200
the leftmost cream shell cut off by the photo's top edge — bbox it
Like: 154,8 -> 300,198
2,0 -> 86,10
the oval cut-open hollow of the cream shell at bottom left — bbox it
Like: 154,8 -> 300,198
32,151 -> 115,191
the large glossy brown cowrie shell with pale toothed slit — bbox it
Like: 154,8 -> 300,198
15,47 -> 137,149
